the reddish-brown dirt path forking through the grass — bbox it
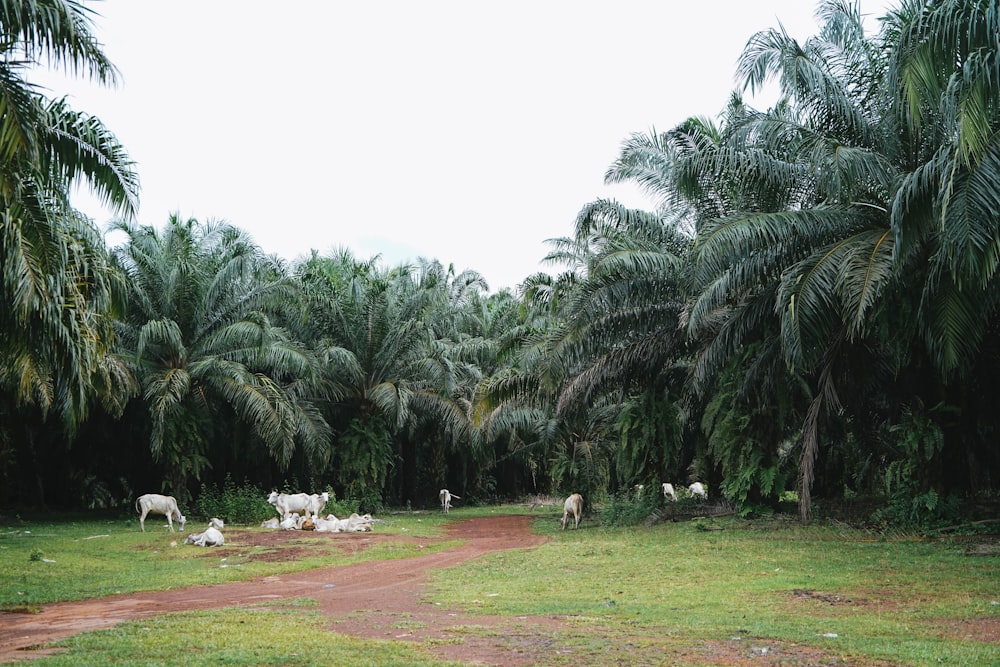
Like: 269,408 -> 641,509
0,516 -> 561,667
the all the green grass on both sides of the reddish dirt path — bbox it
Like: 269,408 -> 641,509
0,506 -> 1000,665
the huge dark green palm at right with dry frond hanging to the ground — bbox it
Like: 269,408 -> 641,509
610,1 -> 998,518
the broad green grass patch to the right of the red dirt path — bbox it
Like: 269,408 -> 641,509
433,519 -> 1000,665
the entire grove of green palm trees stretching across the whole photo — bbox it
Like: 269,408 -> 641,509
0,0 -> 1000,526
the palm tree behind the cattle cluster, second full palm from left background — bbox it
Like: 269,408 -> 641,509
296,250 -> 481,507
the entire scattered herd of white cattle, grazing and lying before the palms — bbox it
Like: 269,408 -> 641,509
135,482 -> 708,547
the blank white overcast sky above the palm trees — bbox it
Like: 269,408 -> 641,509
43,0 -> 890,290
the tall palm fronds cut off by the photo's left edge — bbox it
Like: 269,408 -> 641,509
0,0 -> 138,431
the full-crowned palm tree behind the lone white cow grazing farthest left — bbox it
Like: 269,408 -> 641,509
114,216 -> 330,497
